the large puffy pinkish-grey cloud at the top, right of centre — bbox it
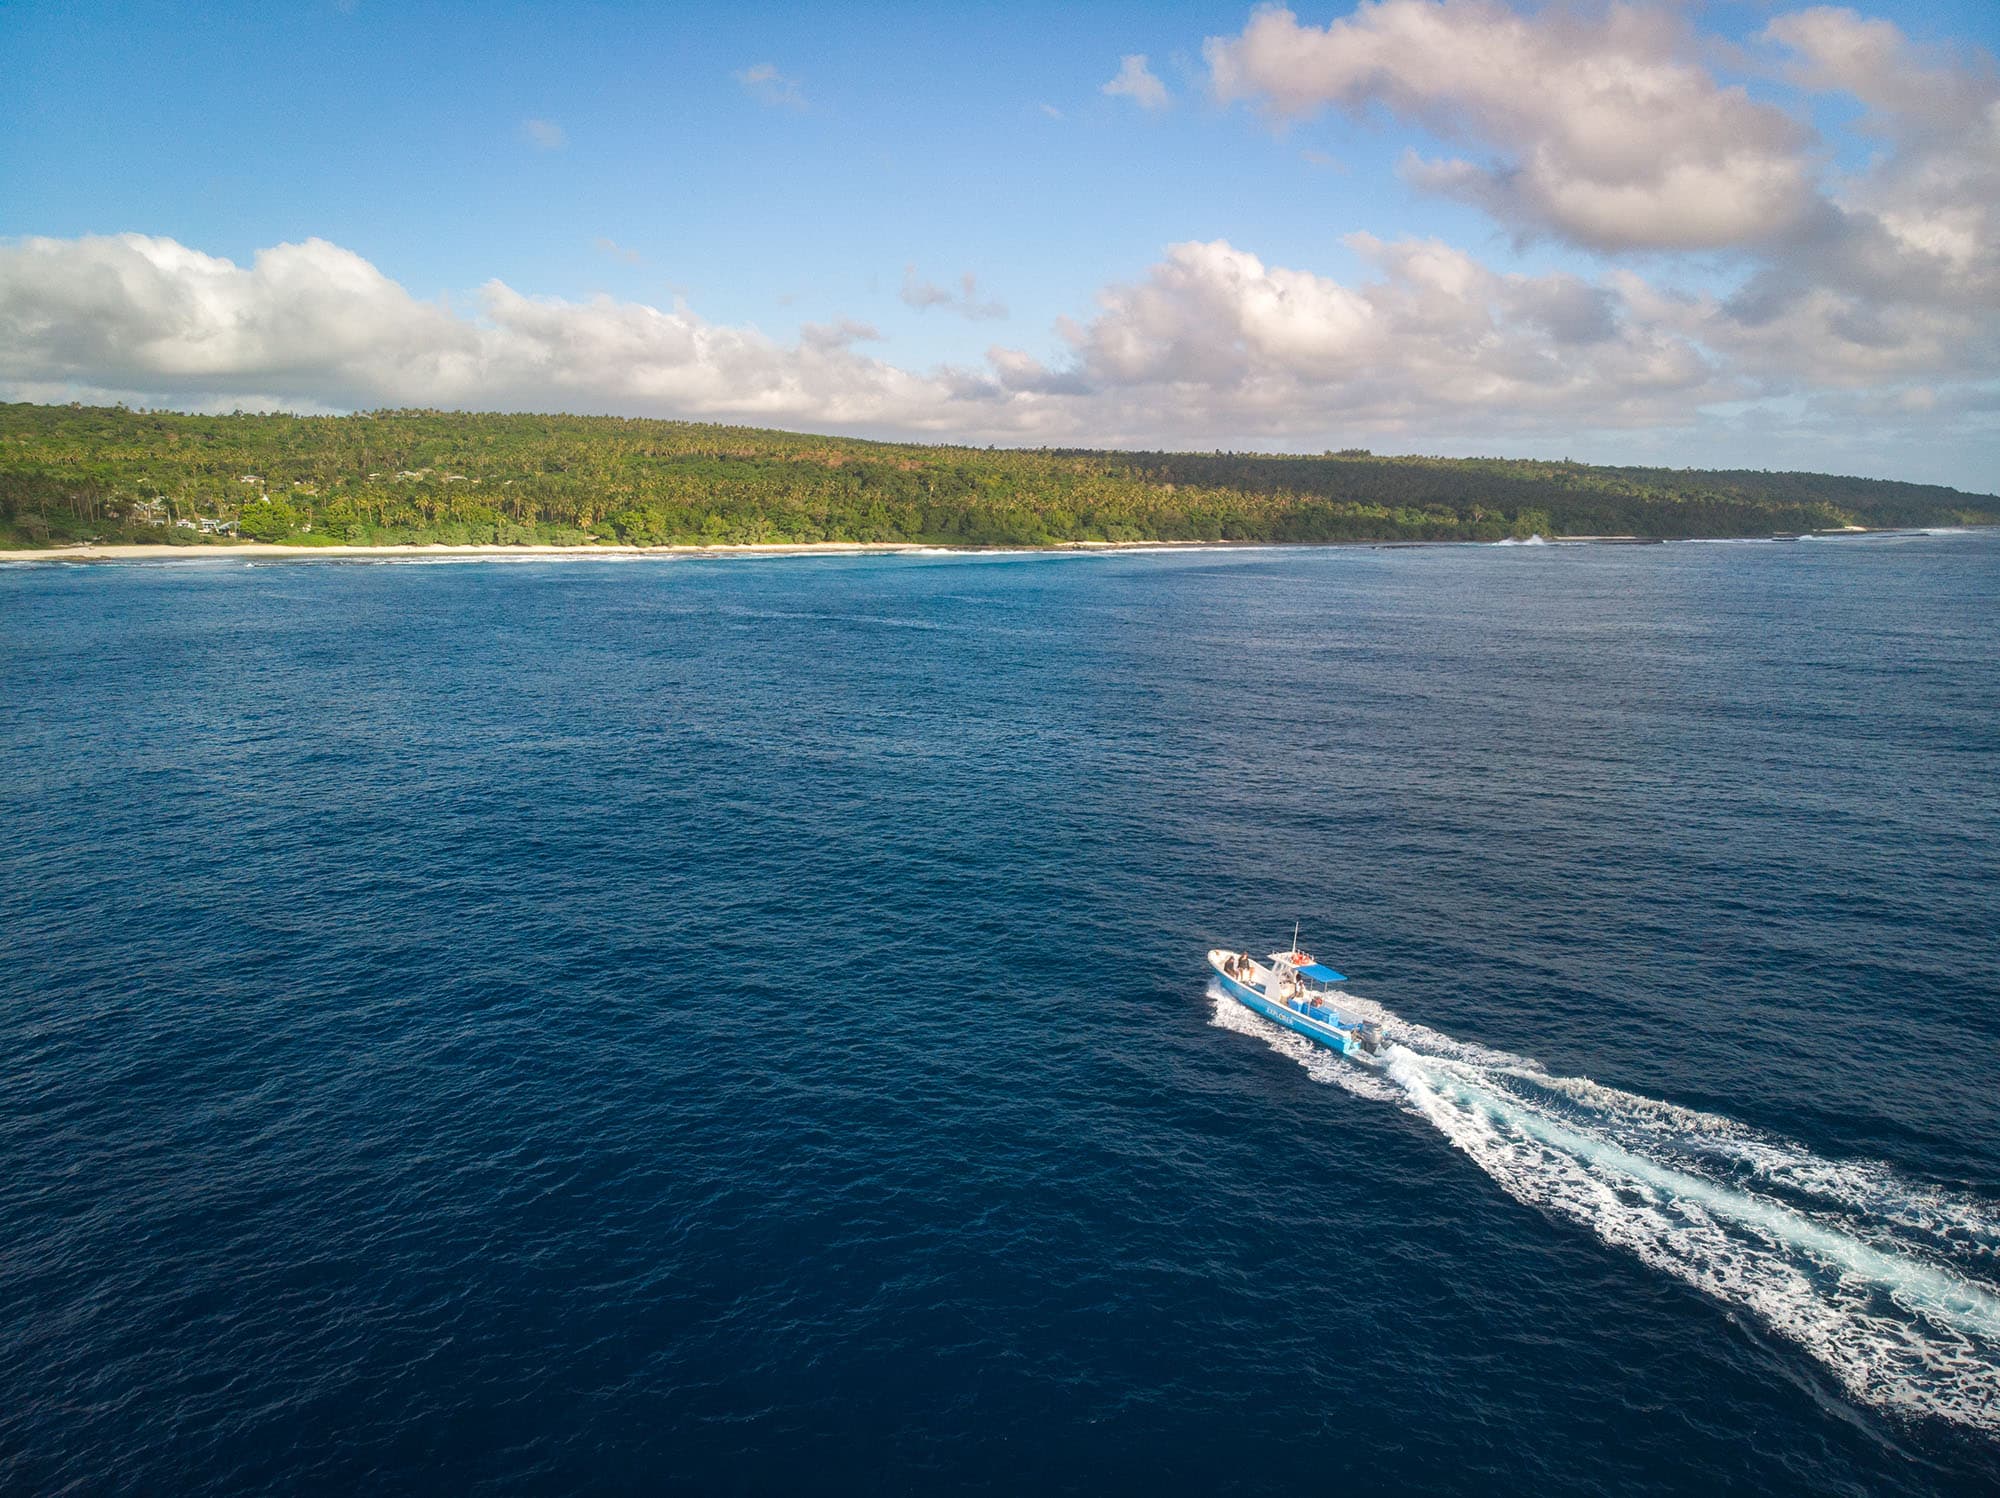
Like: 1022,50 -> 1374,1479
1202,0 -> 1814,250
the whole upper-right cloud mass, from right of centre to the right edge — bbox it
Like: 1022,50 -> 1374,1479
1204,0 -> 2000,318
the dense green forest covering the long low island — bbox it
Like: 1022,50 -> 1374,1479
0,406 -> 2000,546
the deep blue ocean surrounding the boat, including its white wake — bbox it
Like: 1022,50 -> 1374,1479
11,536 -> 2000,1494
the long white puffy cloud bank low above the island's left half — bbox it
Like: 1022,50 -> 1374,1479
0,234 -> 960,428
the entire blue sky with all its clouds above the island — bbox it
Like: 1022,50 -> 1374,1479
0,0 -> 2000,492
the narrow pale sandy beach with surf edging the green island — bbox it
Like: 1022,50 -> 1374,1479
0,526 -> 1958,564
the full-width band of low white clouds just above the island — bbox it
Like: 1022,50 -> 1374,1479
0,234 -> 2000,482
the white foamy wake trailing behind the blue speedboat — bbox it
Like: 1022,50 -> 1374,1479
1210,984 -> 2000,1434
